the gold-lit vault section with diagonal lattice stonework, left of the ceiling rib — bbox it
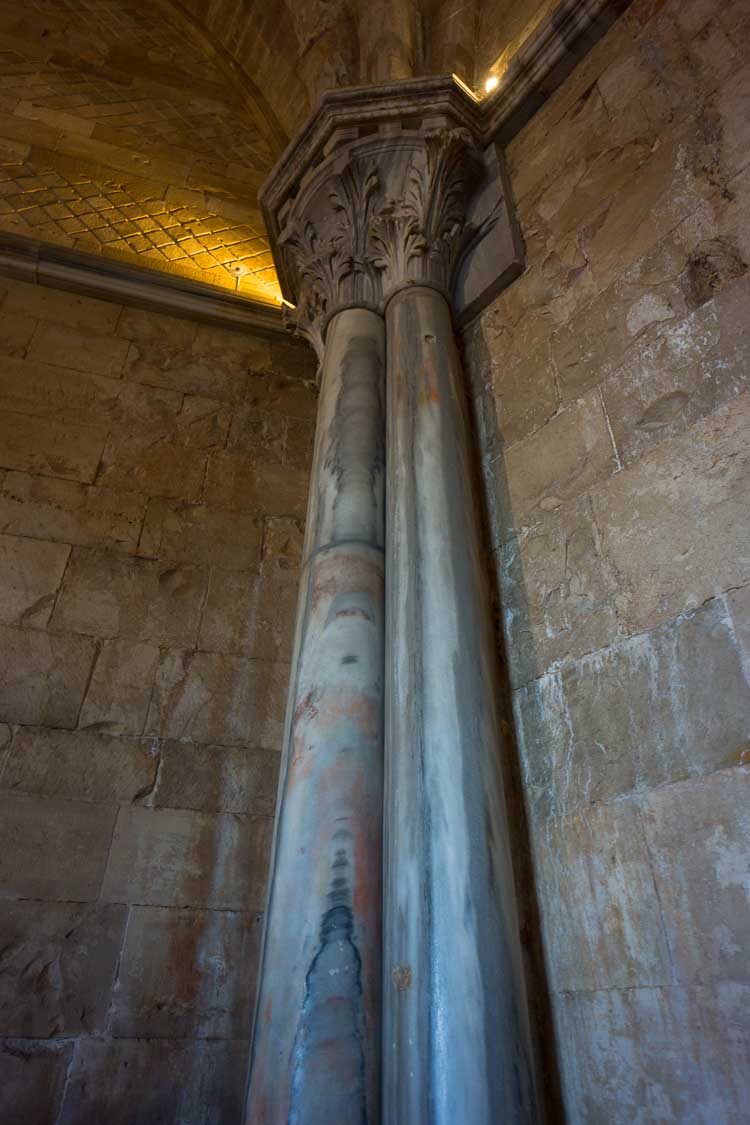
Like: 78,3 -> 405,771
0,0 -> 284,303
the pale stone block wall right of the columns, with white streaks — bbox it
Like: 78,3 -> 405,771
466,0 -> 750,1123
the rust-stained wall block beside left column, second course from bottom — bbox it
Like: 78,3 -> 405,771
111,907 -> 262,1040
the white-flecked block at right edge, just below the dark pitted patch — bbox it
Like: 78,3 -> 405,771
602,272 -> 750,464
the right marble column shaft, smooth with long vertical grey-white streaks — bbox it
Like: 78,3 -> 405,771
383,287 -> 539,1125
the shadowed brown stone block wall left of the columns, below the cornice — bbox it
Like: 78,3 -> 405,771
0,280 -> 315,1125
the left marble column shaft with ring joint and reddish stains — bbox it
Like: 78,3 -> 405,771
246,309 -> 385,1125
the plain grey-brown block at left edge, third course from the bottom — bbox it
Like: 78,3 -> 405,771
0,795 -> 117,902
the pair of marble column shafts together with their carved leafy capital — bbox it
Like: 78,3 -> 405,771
246,79 -> 539,1125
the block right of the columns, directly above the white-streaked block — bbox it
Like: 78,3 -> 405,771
497,497 -> 621,684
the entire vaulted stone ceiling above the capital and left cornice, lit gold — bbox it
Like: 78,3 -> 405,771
0,0 -> 550,303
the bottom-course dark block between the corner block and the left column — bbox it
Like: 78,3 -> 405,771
58,1040 -> 249,1125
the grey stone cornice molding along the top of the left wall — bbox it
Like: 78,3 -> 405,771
0,232 -> 284,335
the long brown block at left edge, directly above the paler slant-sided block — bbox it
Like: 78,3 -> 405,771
0,473 -> 146,554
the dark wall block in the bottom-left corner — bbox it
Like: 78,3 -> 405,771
0,1040 -> 74,1125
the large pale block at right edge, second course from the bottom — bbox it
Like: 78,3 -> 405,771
641,765 -> 750,984
